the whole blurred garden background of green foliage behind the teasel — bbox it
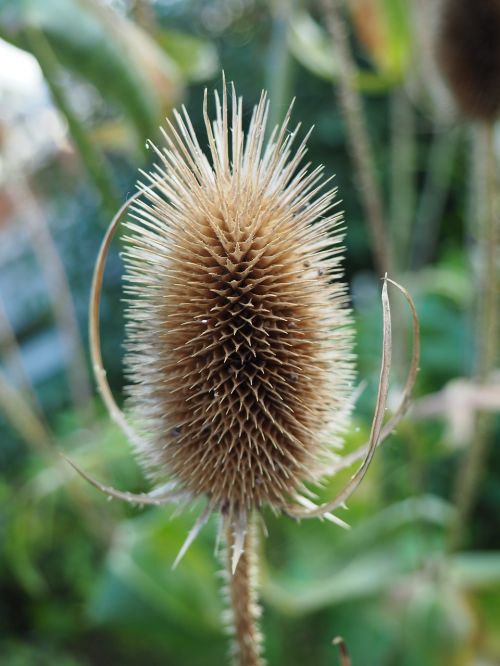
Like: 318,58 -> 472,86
0,0 -> 500,666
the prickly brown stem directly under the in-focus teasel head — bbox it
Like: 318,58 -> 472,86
226,522 -> 264,666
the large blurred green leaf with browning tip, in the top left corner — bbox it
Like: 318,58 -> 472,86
0,0 -> 181,147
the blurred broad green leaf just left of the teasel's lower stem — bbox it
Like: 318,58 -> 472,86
91,509 -> 220,632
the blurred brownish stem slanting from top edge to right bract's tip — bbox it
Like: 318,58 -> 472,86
321,0 -> 392,275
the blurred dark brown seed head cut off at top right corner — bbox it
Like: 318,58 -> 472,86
437,0 -> 500,121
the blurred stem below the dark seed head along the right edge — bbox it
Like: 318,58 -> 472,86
448,124 -> 500,551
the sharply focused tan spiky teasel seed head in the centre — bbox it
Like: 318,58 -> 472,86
125,89 -> 352,544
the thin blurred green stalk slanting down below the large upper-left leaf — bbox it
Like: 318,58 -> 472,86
25,28 -> 119,215
